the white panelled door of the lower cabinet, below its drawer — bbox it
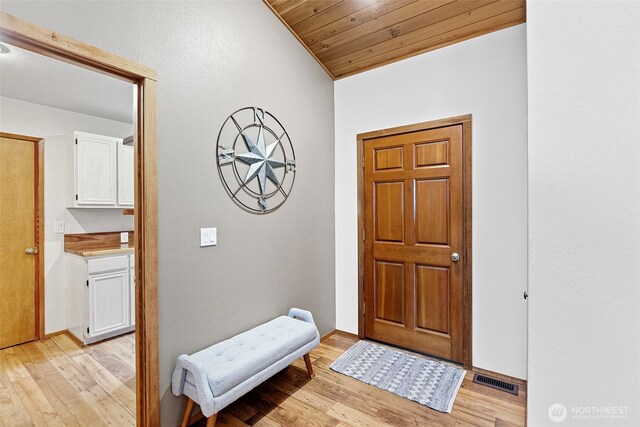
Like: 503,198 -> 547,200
89,269 -> 130,337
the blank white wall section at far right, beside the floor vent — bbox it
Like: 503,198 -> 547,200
527,1 -> 640,427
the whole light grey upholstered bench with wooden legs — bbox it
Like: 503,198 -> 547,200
171,308 -> 320,427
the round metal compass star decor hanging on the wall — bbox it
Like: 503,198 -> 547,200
216,107 -> 296,214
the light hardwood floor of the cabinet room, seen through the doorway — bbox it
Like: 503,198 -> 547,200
0,334 -> 136,427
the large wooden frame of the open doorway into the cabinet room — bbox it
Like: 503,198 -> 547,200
0,12 -> 160,426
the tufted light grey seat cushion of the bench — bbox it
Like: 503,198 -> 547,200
186,316 -> 317,396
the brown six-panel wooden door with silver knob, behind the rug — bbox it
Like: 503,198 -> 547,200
363,125 -> 464,363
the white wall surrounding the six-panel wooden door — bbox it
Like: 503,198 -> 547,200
335,25 -> 527,378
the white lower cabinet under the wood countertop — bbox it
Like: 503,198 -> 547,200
67,254 -> 135,344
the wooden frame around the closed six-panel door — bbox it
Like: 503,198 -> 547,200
356,114 -> 473,369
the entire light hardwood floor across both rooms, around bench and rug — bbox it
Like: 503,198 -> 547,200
0,332 -> 526,427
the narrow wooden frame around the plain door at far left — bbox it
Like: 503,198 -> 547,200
0,132 -> 44,340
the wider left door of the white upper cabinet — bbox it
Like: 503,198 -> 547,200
76,133 -> 118,207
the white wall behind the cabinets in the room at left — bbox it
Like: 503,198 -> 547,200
0,96 -> 133,333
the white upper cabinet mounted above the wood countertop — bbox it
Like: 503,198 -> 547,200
67,132 -> 134,208
